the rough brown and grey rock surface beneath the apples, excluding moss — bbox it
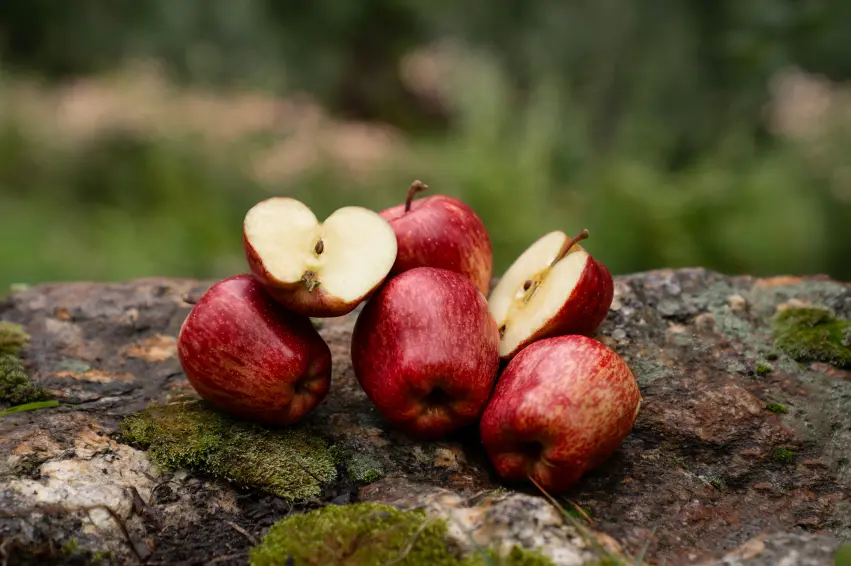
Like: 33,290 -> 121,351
0,269 -> 851,565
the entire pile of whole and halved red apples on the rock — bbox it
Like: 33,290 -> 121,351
178,181 -> 641,492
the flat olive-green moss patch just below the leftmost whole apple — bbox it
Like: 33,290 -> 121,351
120,402 -> 338,501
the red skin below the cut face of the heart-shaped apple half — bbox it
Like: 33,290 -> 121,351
242,233 -> 386,318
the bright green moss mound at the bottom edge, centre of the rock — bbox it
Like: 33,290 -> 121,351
249,503 -> 552,566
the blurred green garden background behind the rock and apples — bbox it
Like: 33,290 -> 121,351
0,0 -> 851,289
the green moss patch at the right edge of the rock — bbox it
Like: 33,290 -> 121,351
772,308 -> 851,368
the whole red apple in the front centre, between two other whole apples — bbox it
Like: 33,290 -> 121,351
352,267 -> 499,439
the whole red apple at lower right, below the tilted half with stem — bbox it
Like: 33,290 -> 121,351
479,335 -> 641,493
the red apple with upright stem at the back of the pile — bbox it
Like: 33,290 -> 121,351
380,181 -> 493,295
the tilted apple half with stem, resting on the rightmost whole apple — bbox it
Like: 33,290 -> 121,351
488,230 -> 614,361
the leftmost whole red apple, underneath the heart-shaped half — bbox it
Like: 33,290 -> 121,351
177,274 -> 331,425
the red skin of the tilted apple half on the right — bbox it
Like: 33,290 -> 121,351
502,255 -> 615,362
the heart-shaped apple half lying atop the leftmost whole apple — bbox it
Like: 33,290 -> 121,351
243,197 -> 397,317
